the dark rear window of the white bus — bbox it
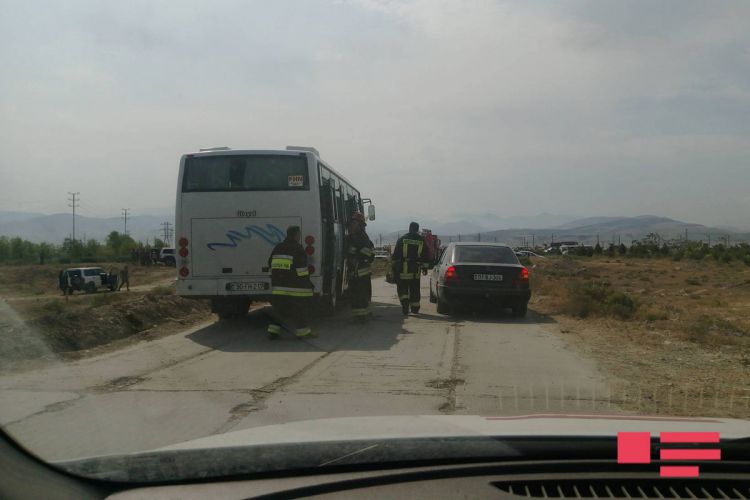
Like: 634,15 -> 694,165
182,155 -> 310,193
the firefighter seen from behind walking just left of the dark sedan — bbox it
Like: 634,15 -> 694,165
392,222 -> 427,316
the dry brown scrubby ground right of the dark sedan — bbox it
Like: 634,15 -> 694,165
530,257 -> 750,418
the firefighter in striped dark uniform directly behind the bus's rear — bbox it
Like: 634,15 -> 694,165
268,226 -> 314,339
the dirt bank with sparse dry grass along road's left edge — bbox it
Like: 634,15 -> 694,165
0,285 -> 213,370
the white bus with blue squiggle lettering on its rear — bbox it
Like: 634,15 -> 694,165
175,146 -> 375,318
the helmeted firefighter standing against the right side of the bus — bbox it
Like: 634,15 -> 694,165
346,212 -> 375,321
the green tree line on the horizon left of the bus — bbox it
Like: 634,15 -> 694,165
0,231 -> 166,264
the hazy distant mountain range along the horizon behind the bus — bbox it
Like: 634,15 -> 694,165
0,208 -> 750,245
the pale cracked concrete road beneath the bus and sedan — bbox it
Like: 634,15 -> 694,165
0,278 -> 617,460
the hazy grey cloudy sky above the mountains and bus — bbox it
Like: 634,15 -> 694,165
0,0 -> 750,225
